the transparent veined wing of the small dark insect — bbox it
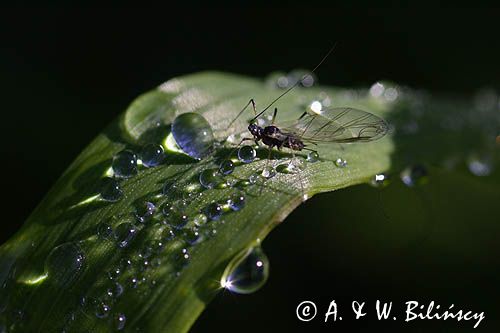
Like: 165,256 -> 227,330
281,108 -> 388,143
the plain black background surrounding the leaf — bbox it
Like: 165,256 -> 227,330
0,5 -> 500,332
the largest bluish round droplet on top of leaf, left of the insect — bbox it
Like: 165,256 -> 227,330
172,112 -> 214,160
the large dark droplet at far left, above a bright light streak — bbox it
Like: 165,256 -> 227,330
45,242 -> 85,286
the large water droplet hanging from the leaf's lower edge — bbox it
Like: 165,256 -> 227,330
221,246 -> 269,294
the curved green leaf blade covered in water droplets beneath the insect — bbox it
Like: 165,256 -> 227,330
0,72 -> 428,332
